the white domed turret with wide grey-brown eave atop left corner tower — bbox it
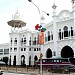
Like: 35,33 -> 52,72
7,10 -> 26,29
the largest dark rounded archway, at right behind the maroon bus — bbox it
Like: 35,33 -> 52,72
61,46 -> 74,58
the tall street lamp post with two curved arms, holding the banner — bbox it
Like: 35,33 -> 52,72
28,0 -> 49,75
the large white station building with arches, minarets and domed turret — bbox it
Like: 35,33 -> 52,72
0,0 -> 75,65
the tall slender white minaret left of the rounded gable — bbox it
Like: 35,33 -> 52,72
52,1 -> 58,57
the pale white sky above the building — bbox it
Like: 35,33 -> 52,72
0,0 -> 72,44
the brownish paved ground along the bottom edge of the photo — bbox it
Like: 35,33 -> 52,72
1,67 -> 75,75
